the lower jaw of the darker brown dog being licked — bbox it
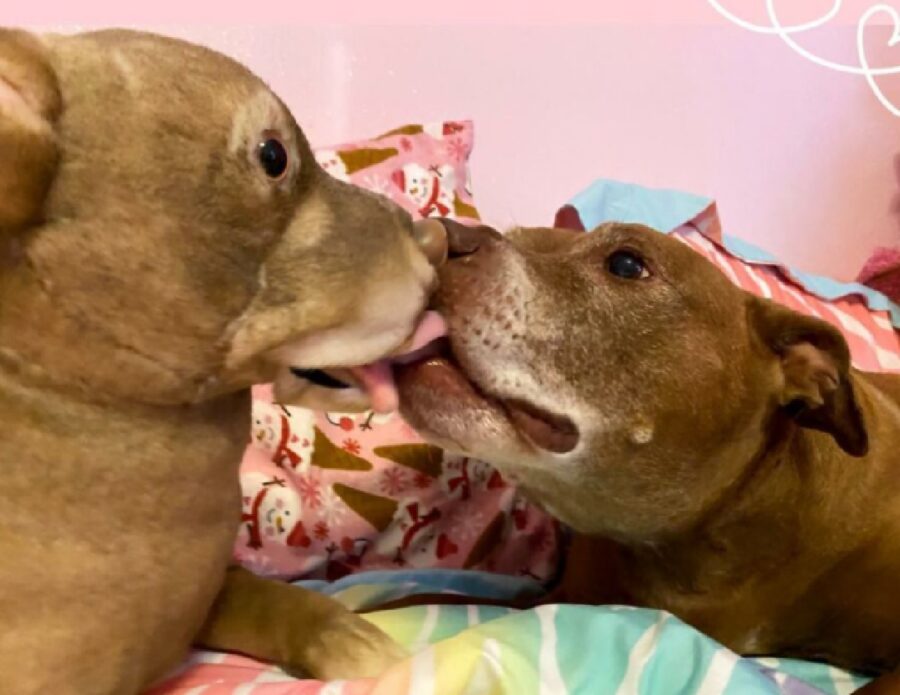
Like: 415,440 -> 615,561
396,354 -> 579,462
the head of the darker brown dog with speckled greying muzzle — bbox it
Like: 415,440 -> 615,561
399,221 -> 867,541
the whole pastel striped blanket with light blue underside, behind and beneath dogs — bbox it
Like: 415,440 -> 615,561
152,181 -> 900,695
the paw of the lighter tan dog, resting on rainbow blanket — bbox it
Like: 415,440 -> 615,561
285,609 -> 409,680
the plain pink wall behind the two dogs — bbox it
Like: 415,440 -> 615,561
19,9 -> 900,279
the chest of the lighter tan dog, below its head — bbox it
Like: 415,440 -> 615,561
0,370 -> 249,693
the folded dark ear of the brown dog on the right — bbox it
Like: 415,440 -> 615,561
749,297 -> 869,456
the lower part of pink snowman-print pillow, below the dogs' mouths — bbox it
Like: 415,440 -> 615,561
235,388 -> 557,581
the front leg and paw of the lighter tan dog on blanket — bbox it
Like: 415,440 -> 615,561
196,567 -> 406,680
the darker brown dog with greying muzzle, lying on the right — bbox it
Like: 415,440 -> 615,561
399,222 -> 900,683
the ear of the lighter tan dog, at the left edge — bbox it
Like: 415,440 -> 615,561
0,29 -> 61,234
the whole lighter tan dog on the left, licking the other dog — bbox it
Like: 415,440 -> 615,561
0,31 -> 444,695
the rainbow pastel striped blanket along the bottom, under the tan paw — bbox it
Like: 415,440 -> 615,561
152,570 -> 866,695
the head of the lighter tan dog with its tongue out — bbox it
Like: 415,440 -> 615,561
0,30 -> 443,409
